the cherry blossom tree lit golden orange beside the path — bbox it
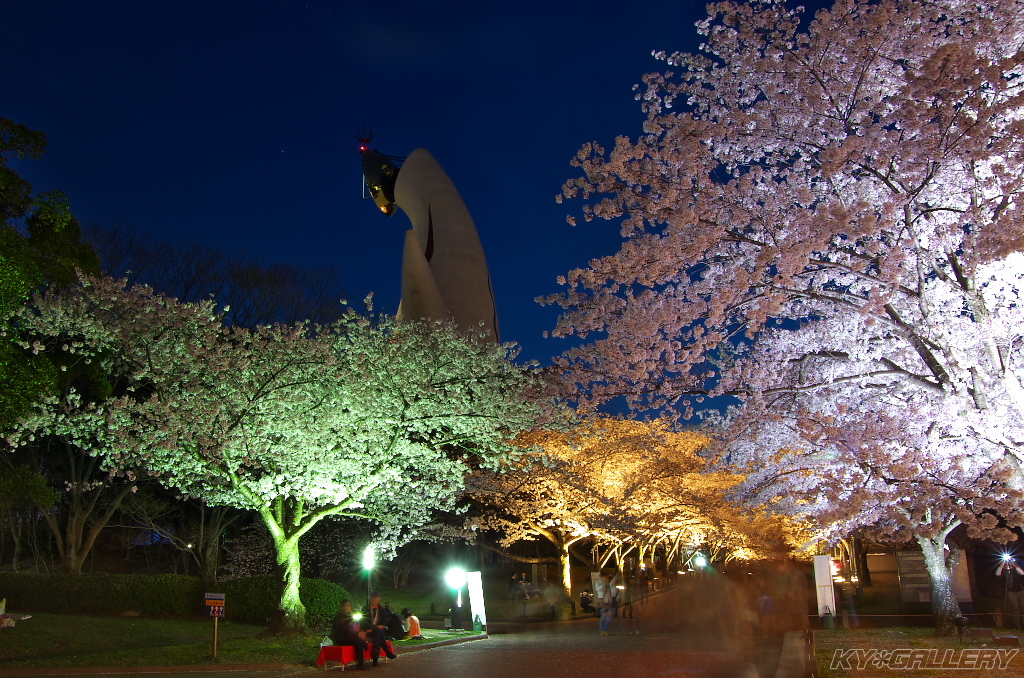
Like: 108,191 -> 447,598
468,418 -> 763,594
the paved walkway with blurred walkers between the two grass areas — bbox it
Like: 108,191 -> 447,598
0,587 -> 782,678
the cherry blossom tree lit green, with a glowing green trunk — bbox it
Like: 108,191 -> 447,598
9,279 -> 540,630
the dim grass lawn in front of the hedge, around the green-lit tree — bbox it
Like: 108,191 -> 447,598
0,615 -> 479,670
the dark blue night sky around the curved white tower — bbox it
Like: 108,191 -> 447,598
0,0 -> 703,362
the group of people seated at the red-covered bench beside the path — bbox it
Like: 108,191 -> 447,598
331,591 -> 423,669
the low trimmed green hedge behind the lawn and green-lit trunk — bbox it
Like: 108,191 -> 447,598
0,573 -> 349,628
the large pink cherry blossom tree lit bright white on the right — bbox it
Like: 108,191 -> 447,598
548,0 -> 1024,631
